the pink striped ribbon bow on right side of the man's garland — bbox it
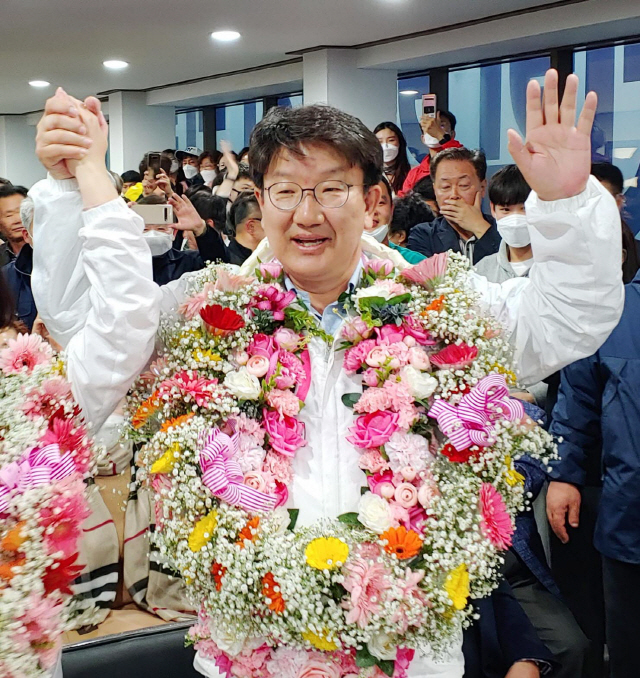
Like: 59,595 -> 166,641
429,374 -> 524,452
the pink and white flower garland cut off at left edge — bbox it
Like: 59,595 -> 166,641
0,334 -> 96,678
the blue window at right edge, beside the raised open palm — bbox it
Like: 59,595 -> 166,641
573,43 -> 640,234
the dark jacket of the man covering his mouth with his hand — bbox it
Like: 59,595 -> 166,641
407,214 -> 501,265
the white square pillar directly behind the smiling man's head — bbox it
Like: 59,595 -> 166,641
303,49 -> 398,129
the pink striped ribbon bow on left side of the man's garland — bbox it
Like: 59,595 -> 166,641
200,428 -> 276,512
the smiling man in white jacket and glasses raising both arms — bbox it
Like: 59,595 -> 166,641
31,71 -> 623,678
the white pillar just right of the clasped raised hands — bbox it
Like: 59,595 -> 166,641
109,92 -> 176,173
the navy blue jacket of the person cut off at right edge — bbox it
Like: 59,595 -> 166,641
550,273 -> 640,564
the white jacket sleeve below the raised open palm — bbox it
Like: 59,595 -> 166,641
471,177 -> 624,384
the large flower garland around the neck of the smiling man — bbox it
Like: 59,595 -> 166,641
129,255 -> 554,678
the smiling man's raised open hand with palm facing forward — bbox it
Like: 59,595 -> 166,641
508,69 -> 598,200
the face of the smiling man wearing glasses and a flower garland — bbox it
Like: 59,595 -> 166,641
256,145 -> 380,293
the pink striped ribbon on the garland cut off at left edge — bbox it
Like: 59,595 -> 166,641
0,443 -> 76,513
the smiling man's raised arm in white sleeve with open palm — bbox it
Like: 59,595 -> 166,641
473,71 -> 624,384
